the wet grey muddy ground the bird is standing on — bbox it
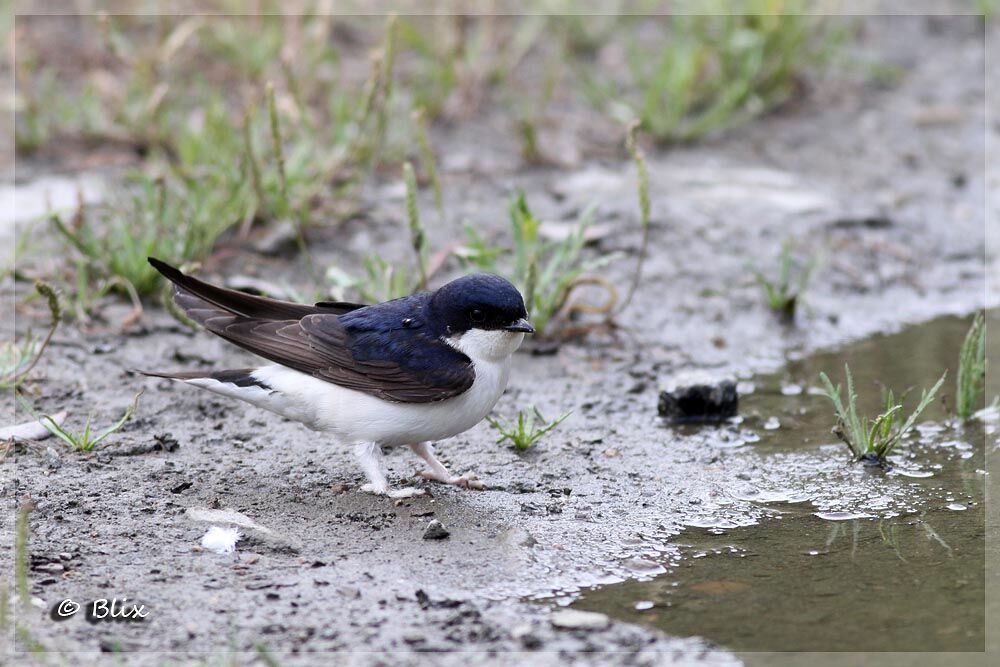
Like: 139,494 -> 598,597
3,17 -> 997,665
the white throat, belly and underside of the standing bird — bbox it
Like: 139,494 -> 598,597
180,329 -> 524,494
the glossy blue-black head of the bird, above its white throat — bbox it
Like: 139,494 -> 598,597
430,273 -> 535,334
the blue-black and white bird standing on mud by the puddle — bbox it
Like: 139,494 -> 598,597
139,257 -> 535,498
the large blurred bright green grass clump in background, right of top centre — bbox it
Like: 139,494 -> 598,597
582,7 -> 840,142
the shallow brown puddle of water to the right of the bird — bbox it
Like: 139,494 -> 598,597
573,312 -> 1000,651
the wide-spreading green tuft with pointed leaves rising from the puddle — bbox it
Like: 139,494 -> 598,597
819,364 -> 947,466
